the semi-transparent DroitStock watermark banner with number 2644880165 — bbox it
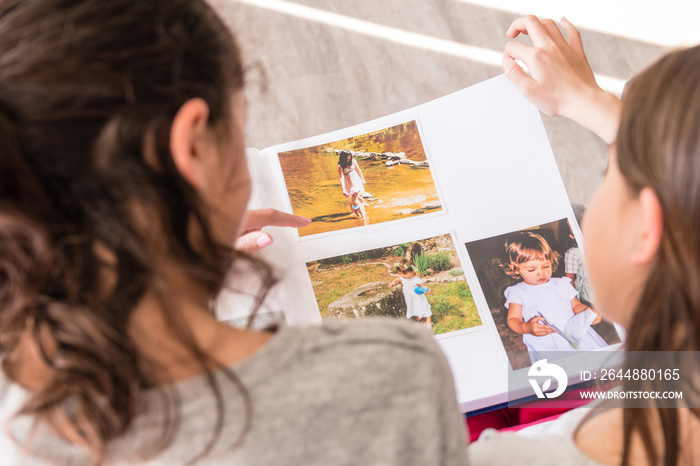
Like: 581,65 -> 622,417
508,351 -> 700,408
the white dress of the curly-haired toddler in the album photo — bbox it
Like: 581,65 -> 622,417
504,277 -> 607,362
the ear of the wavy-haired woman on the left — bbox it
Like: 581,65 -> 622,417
170,98 -> 211,190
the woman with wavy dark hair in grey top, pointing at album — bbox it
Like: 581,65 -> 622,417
0,0 -> 466,465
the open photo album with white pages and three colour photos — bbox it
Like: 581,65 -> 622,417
215,76 -> 621,413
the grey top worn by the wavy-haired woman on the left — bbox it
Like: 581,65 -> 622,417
0,320 -> 467,466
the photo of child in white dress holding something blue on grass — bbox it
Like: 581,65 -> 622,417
306,235 -> 481,335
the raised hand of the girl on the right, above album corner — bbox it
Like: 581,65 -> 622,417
503,15 -> 622,143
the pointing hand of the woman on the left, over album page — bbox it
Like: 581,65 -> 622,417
234,209 -> 311,253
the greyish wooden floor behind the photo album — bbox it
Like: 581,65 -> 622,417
212,0 -> 667,204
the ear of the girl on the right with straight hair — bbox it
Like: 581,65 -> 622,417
631,187 -> 664,265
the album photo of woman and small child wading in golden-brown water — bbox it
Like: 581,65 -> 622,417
278,120 -> 442,236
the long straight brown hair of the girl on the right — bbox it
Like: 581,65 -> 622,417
616,47 -> 700,466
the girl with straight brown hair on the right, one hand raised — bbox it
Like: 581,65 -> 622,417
470,16 -> 700,466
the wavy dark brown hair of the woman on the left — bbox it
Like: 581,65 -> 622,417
0,0 -> 269,462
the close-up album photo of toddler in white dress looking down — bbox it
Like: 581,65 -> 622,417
466,219 -> 620,370
